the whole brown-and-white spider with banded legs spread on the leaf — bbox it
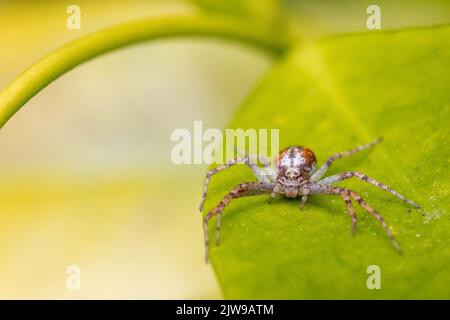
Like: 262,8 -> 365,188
200,138 -> 419,261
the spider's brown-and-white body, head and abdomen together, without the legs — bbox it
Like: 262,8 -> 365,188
274,146 -> 316,198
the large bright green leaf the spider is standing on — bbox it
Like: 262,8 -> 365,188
205,26 -> 450,299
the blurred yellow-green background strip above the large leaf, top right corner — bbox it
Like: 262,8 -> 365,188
281,0 -> 450,38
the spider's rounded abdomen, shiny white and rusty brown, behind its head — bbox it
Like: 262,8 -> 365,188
275,146 -> 316,177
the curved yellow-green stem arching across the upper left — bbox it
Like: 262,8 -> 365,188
0,14 -> 287,128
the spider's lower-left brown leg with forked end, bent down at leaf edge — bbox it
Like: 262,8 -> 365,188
203,182 -> 273,262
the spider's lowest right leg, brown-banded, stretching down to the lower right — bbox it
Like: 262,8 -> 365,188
309,184 -> 402,254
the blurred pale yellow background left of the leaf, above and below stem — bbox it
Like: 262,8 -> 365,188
0,0 -> 271,299
